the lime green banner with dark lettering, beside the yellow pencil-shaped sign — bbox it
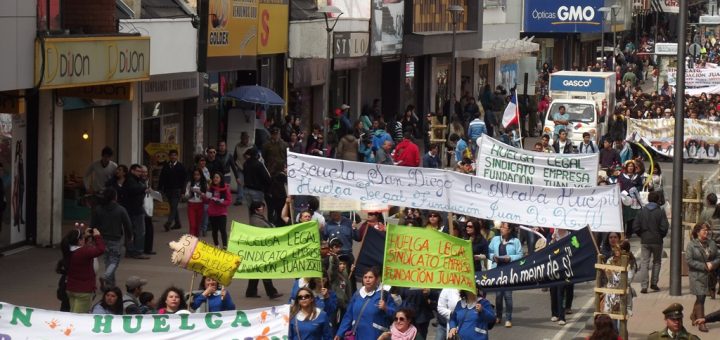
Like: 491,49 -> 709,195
227,221 -> 322,279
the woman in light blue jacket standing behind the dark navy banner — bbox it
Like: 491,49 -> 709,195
488,222 -> 523,328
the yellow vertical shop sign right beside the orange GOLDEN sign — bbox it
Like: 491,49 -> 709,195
257,0 -> 290,54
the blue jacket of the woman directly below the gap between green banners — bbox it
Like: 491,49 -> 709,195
336,288 -> 396,340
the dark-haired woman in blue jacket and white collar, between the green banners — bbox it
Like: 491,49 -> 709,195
335,267 -> 395,340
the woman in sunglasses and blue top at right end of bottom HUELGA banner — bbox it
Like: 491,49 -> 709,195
288,287 -> 332,340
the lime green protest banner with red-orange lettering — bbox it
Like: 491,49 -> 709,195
383,225 -> 475,291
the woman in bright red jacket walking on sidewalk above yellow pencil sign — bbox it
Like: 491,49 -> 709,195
203,172 -> 232,248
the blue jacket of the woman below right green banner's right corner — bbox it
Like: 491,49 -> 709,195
448,299 -> 495,340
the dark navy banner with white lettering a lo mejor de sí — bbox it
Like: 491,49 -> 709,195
475,229 -> 598,291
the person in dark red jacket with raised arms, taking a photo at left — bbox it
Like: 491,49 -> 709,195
60,228 -> 105,313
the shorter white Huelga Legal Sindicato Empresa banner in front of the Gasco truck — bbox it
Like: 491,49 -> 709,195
475,134 -> 599,188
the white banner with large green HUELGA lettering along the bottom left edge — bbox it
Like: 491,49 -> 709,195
0,302 -> 290,340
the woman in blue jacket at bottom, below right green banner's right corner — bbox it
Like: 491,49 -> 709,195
448,291 -> 495,340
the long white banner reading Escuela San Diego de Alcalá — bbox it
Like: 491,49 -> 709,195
287,152 -> 622,231
